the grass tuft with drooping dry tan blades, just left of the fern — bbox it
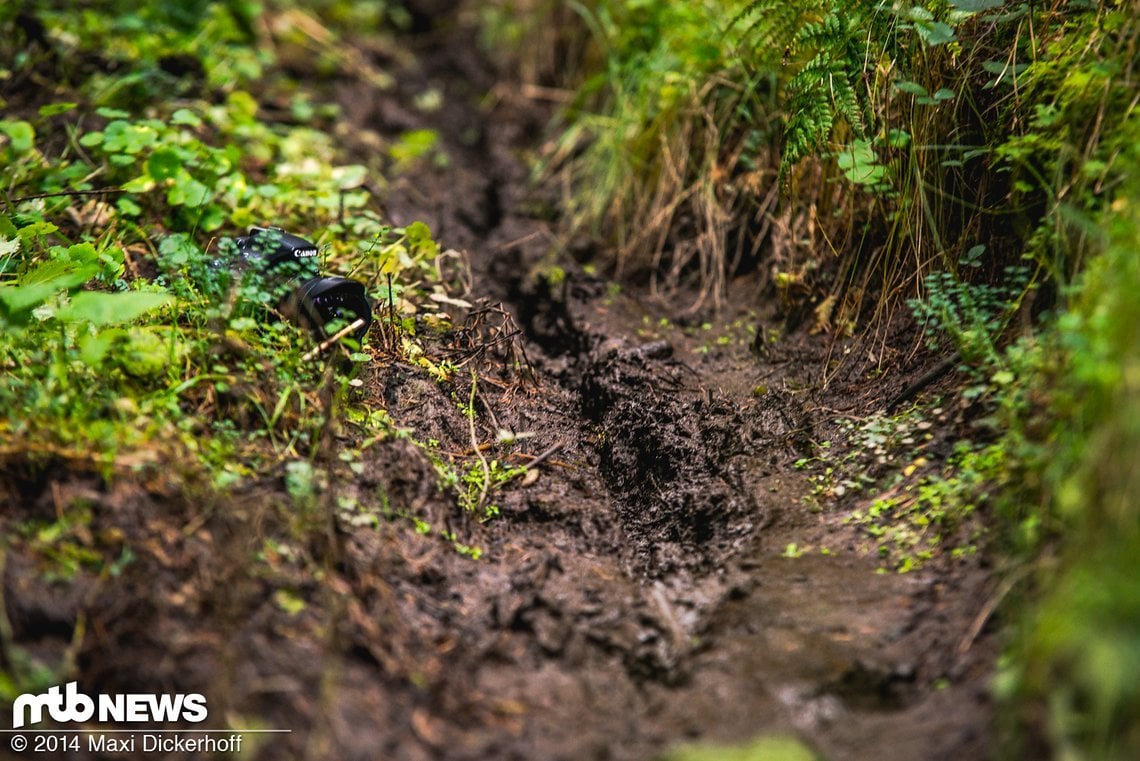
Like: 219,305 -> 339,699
543,0 -> 770,300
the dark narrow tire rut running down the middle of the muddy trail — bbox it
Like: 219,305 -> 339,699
342,16 -> 774,656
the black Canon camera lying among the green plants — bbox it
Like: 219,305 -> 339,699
230,227 -> 372,341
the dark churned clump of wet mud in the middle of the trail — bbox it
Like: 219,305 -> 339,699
580,342 -> 751,578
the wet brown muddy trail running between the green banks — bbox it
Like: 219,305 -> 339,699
0,11 -> 996,761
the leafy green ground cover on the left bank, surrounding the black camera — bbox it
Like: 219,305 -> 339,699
0,3 -> 521,701
